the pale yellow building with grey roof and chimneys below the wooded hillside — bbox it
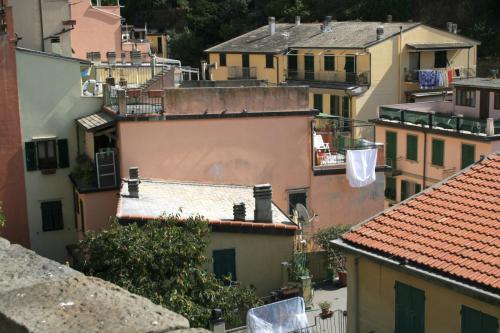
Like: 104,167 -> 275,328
205,17 -> 478,120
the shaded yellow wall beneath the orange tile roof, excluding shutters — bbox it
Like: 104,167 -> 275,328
347,255 -> 500,333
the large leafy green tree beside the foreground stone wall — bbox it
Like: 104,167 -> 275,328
79,216 -> 260,327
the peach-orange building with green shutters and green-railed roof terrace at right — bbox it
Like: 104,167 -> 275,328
373,78 -> 500,204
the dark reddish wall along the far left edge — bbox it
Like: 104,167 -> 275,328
0,3 -> 30,247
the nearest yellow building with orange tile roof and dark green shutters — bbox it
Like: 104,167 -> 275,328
333,153 -> 500,333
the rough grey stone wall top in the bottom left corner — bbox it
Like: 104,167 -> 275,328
0,238 -> 206,333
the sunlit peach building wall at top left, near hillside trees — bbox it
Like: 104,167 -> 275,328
71,0 -> 122,59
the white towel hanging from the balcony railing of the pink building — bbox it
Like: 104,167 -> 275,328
346,149 -> 377,187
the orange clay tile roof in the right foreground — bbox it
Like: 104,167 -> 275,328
342,153 -> 500,290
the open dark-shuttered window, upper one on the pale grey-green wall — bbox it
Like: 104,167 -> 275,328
24,139 -> 69,171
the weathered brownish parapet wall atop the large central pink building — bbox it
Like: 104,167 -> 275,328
164,87 -> 308,115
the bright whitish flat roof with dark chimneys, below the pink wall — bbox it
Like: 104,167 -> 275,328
116,179 -> 298,230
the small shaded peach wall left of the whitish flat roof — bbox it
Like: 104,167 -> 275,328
77,190 -> 118,235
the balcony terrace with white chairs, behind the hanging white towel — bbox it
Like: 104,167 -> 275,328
312,116 -> 386,174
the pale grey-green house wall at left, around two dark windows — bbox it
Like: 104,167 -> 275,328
17,51 -> 102,261
